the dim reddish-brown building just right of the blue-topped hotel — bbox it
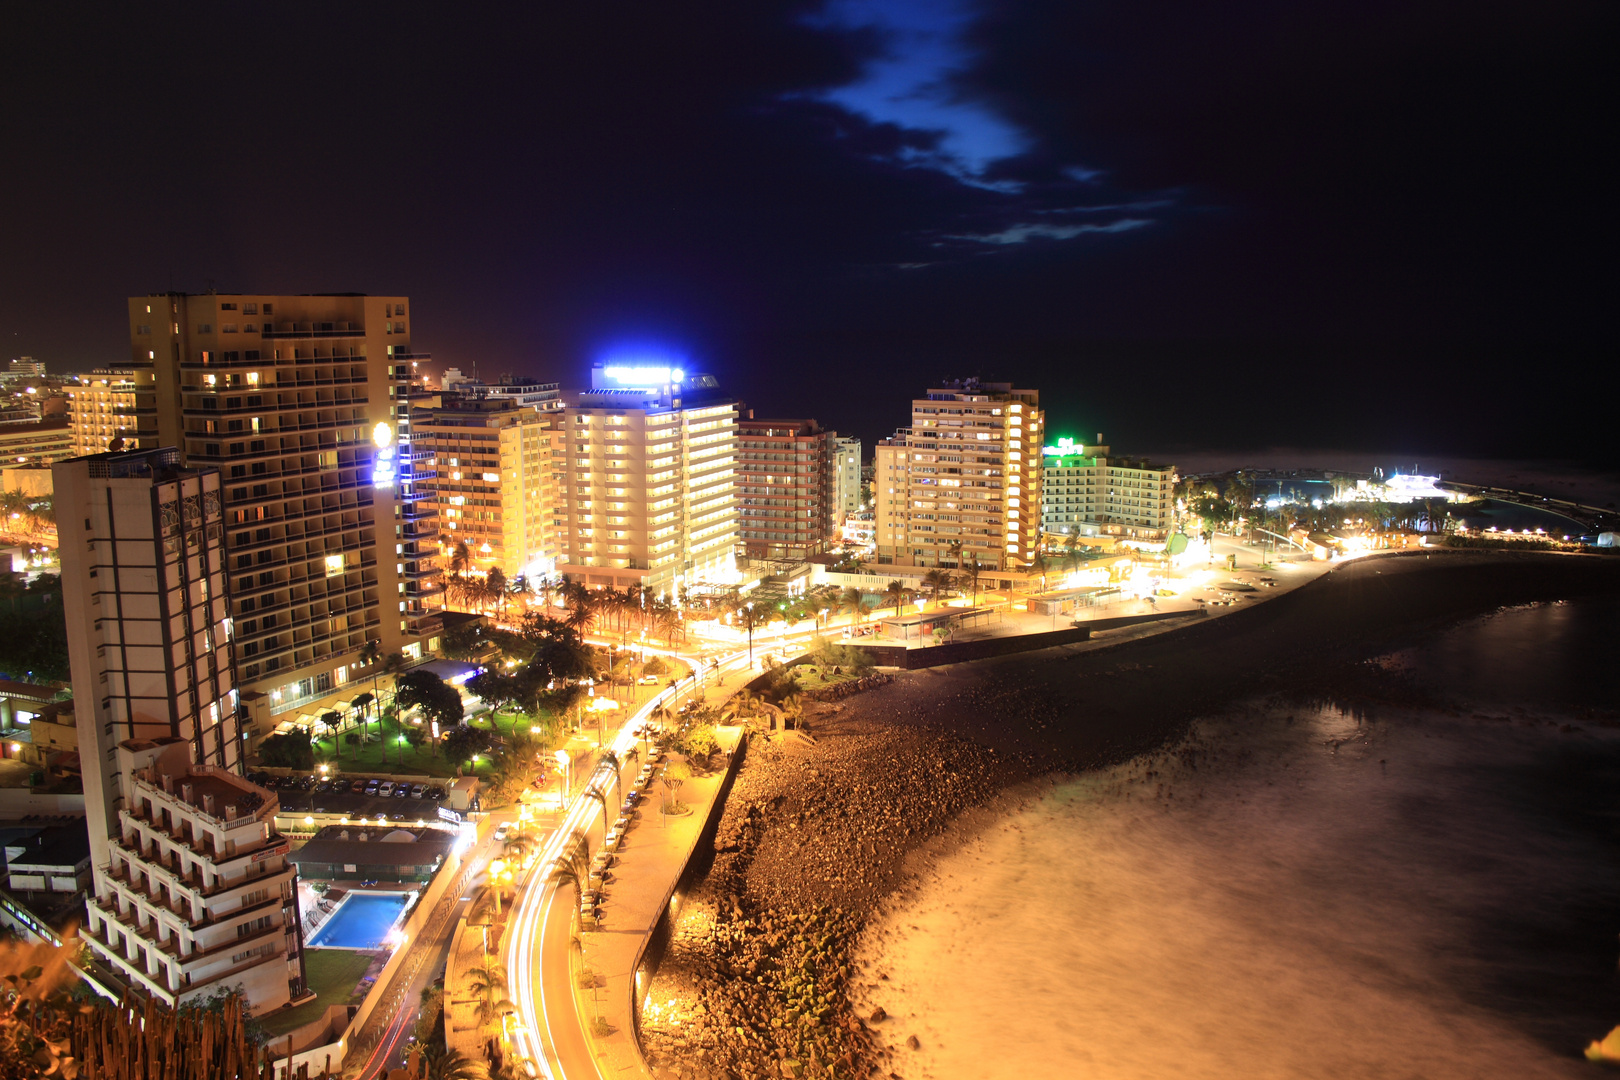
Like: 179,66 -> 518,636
737,418 -> 835,559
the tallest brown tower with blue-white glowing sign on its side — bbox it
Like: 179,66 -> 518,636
130,293 -> 442,719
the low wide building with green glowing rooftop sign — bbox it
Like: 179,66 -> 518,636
1040,434 -> 1176,541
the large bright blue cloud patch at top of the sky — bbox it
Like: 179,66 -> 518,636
807,0 -> 1032,189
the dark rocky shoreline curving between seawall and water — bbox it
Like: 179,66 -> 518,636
642,555 -> 1620,1080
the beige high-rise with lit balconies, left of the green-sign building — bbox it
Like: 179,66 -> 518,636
876,379 -> 1043,570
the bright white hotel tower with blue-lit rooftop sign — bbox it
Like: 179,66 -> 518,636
559,364 -> 737,596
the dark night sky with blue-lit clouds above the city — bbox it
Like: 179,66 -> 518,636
0,0 -> 1620,465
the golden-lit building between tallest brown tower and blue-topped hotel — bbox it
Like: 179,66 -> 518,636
413,397 -> 569,578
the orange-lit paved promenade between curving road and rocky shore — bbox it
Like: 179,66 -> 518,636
569,727 -> 742,1080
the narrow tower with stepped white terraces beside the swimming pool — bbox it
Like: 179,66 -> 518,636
52,449 -> 305,1014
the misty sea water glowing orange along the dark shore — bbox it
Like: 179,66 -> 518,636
859,601 -> 1620,1080
